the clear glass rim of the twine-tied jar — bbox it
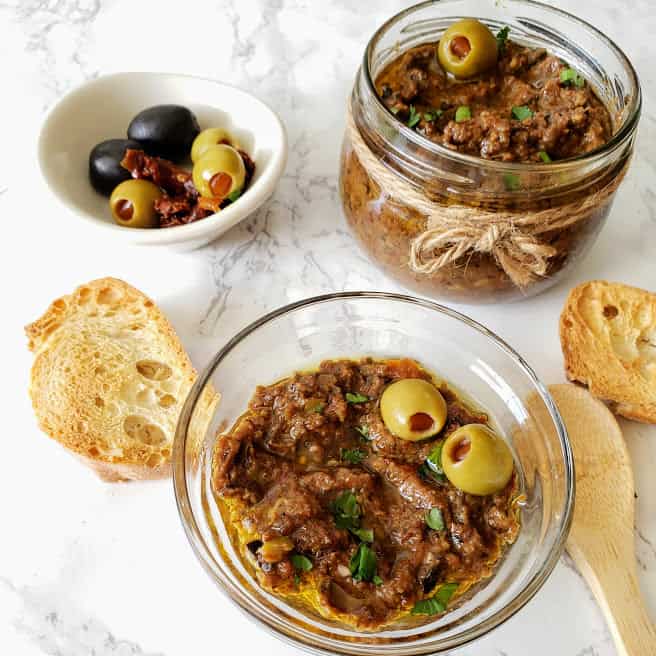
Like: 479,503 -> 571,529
362,0 -> 642,173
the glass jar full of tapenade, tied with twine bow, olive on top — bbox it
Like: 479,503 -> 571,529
340,0 -> 641,303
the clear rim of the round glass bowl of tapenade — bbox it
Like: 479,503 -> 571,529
172,291 -> 576,656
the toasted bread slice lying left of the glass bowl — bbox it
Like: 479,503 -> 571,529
26,278 -> 215,481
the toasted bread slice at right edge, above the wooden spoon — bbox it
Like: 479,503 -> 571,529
560,280 -> 656,423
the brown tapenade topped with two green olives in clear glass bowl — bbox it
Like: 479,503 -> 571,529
212,359 -> 519,630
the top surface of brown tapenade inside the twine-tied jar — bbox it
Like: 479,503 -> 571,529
376,26 -> 612,162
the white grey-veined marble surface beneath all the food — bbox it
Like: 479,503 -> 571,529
0,0 -> 656,656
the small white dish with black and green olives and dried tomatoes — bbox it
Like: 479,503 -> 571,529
38,73 -> 287,250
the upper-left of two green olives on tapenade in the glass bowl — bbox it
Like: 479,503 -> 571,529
380,378 -> 446,442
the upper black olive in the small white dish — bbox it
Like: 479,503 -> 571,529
128,105 -> 200,162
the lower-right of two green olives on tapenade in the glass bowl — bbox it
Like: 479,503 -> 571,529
442,424 -> 513,496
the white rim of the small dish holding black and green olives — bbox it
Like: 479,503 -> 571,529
37,71 -> 288,246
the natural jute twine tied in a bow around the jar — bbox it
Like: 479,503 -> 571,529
347,103 -> 627,288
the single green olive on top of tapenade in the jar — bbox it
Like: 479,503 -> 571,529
437,18 -> 497,79
